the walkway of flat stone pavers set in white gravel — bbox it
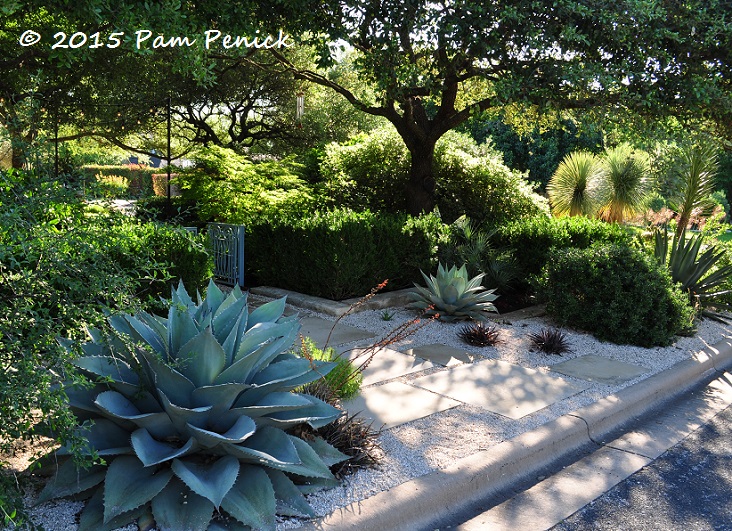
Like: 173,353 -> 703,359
294,317 -> 647,428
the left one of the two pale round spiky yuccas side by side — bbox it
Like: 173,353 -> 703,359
546,151 -> 602,216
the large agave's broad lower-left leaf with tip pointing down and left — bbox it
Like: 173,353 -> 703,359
104,456 -> 173,523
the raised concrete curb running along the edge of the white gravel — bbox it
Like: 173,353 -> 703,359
305,339 -> 732,531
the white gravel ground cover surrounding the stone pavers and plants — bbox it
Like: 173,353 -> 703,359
10,296 -> 732,531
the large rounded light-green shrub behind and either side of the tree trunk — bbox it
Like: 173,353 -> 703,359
321,127 -> 547,223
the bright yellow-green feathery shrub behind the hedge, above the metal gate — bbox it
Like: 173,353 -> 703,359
175,146 -> 316,224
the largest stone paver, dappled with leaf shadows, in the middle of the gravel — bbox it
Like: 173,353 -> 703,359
411,360 -> 588,419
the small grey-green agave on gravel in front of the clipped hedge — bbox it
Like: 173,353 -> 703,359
409,264 -> 498,321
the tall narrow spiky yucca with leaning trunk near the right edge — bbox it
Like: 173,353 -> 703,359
670,144 -> 719,239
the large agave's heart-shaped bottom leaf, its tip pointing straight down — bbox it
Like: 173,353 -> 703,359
171,455 -> 239,509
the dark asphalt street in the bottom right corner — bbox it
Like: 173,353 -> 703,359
552,407 -> 732,531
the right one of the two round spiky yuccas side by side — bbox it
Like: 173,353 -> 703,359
598,144 -> 652,223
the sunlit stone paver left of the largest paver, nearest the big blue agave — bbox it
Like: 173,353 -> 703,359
343,382 -> 460,429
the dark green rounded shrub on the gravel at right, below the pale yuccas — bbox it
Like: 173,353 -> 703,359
542,244 -> 694,347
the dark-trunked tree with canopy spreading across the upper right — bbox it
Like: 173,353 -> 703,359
274,0 -> 732,213
